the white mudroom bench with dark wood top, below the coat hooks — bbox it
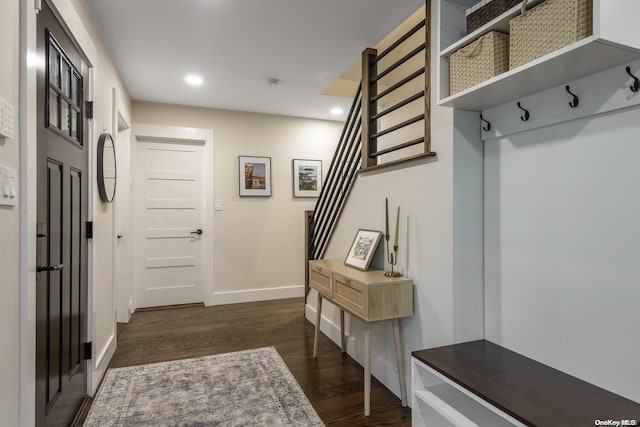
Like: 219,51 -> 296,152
411,340 -> 640,427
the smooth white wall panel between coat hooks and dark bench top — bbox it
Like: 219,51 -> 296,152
485,107 -> 640,401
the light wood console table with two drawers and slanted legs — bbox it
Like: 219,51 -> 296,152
309,260 -> 413,416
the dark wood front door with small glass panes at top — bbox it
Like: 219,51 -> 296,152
36,1 -> 89,426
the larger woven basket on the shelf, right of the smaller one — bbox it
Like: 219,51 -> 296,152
509,0 -> 593,69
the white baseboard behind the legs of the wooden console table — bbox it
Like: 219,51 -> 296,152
305,304 -> 404,405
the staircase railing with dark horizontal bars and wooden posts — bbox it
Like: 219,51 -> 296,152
305,9 -> 436,295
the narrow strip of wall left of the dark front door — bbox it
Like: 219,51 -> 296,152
0,0 -> 20,426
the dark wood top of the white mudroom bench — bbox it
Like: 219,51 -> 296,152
412,340 -> 640,426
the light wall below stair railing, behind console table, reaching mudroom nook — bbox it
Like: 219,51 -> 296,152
307,2 -> 484,402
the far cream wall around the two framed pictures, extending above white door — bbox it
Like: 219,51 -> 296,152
133,102 -> 342,305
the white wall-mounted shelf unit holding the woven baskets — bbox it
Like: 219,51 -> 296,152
438,0 -> 640,111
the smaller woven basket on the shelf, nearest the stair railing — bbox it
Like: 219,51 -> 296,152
449,31 -> 509,95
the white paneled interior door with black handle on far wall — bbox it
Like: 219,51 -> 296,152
135,138 -> 206,307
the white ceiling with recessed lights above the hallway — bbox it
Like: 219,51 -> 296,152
84,0 -> 424,121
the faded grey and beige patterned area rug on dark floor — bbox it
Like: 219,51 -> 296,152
84,347 -> 324,427
